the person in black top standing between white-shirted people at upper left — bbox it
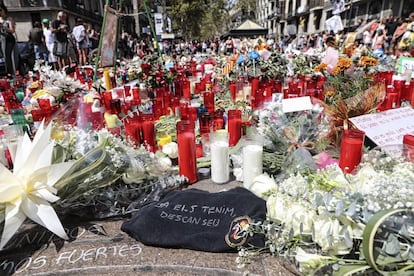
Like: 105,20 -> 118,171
51,11 -> 69,70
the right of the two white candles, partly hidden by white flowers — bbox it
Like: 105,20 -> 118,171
243,144 -> 263,188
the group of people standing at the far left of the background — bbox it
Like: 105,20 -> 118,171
0,3 -> 100,77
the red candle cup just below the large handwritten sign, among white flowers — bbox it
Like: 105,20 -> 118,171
339,129 -> 365,173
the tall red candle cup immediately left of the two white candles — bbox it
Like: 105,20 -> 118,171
176,120 -> 197,184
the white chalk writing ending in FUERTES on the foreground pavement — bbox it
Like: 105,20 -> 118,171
0,224 -> 142,275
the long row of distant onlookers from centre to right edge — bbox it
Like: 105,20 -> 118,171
118,12 -> 414,66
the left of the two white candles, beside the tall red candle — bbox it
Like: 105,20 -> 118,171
210,140 -> 230,184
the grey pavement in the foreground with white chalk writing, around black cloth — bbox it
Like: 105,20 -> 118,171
0,180 -> 299,276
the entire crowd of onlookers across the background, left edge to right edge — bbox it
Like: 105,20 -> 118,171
0,3 -> 414,76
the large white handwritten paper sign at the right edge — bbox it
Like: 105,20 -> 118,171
349,106 -> 414,147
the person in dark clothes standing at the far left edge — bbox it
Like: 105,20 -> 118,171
0,3 -> 19,77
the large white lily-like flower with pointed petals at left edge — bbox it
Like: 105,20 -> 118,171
0,123 -> 73,249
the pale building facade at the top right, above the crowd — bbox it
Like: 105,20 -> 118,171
256,0 -> 414,38
